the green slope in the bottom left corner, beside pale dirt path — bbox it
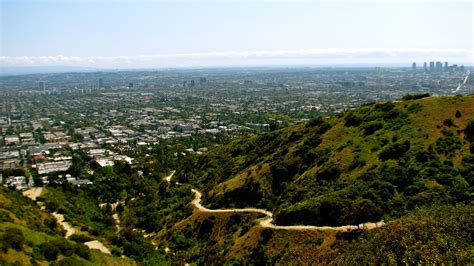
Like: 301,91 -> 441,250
0,187 -> 134,265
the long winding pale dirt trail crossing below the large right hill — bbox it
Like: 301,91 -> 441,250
191,189 -> 385,231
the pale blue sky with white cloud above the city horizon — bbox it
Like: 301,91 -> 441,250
0,0 -> 474,68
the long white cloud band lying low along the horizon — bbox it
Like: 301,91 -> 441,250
0,48 -> 474,68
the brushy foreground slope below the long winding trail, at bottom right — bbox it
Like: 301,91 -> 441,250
157,204 -> 474,265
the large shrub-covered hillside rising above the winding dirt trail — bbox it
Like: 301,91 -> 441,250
177,95 -> 474,226
